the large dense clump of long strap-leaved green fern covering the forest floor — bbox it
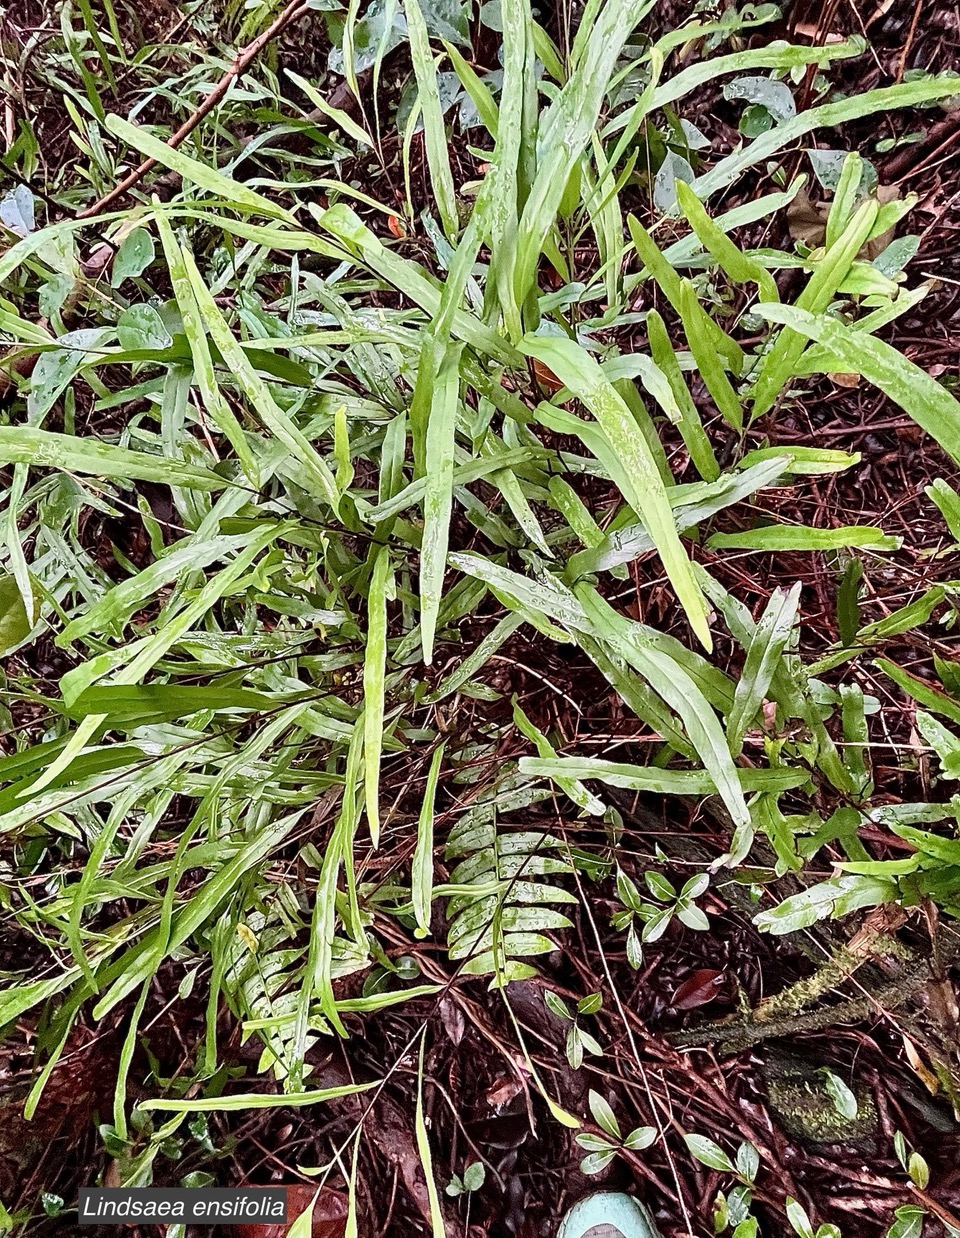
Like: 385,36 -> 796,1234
0,0 -> 960,1138
